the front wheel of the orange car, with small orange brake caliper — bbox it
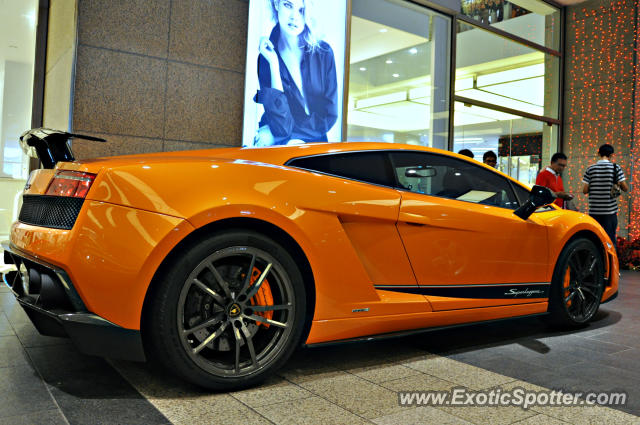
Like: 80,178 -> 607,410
549,238 -> 604,327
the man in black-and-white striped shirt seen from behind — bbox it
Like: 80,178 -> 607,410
582,143 -> 629,246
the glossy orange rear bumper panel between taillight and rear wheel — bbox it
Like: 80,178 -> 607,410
11,199 -> 193,330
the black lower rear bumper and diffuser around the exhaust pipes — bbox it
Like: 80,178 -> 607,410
2,243 -> 145,361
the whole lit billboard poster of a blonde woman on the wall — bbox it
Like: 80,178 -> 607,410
242,0 -> 348,147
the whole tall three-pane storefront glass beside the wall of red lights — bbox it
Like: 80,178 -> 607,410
453,7 -> 561,185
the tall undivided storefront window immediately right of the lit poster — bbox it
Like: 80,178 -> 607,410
346,0 -> 451,149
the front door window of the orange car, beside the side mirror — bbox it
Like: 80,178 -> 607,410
391,152 -> 519,209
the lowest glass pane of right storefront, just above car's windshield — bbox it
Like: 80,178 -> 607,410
453,102 -> 558,185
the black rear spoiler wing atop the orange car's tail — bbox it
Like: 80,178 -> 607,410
20,128 -> 106,168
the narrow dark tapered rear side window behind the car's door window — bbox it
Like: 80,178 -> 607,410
287,152 -> 395,186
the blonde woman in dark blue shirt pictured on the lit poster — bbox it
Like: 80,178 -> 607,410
253,0 -> 339,146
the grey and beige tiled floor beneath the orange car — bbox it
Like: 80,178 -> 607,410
0,272 -> 640,425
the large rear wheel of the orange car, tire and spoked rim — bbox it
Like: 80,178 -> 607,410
143,230 -> 306,390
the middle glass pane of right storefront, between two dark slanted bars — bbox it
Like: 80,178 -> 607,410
455,22 -> 560,118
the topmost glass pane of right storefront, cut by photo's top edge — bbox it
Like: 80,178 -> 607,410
461,0 -> 560,50
